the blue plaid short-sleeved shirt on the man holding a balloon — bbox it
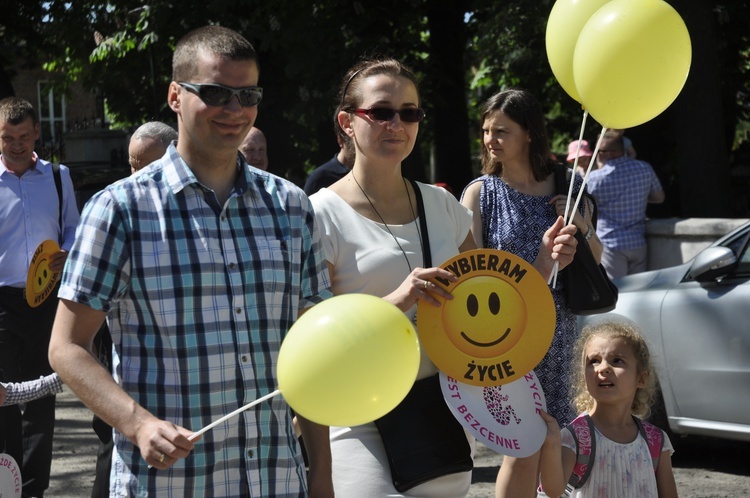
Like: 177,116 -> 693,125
59,145 -> 331,498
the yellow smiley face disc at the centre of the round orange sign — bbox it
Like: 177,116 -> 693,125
443,276 -> 527,358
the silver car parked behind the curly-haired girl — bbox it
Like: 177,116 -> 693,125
578,222 -> 750,441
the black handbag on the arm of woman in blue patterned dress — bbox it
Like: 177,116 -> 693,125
555,164 -> 618,315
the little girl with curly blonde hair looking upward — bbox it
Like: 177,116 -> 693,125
541,322 -> 677,498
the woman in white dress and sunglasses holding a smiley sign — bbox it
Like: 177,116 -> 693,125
310,59 -> 572,498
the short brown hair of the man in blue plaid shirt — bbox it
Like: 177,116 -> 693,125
172,26 -> 258,82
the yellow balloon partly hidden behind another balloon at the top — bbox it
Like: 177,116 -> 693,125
546,0 -> 609,102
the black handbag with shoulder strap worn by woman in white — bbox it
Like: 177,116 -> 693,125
375,181 -> 474,492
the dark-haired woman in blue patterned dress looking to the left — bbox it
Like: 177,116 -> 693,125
461,90 -> 602,498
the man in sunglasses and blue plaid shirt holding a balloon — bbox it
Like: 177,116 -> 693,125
49,26 -> 333,498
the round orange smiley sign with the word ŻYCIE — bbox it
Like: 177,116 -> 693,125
417,249 -> 555,386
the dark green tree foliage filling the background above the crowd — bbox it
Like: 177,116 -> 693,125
0,0 -> 750,215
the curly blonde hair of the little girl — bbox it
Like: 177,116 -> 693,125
570,321 -> 656,418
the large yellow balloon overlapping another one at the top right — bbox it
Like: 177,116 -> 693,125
573,0 -> 692,128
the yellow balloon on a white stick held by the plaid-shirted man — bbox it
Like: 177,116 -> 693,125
276,294 -> 420,426
